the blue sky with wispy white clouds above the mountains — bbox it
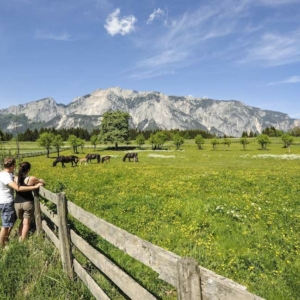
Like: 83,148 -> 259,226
0,0 -> 300,119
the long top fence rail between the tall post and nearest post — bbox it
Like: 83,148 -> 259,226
68,201 -> 180,288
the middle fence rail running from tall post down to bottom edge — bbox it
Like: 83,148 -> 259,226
71,230 -> 156,300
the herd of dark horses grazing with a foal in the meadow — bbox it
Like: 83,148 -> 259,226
53,153 -> 138,168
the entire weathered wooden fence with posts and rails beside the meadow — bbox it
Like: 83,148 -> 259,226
34,187 -> 262,300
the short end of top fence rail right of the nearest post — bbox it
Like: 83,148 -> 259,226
200,267 -> 264,300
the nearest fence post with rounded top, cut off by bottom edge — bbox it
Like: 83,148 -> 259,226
177,257 -> 202,300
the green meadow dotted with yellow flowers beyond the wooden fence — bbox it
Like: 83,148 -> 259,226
3,138 -> 300,300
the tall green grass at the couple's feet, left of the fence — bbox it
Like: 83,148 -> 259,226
0,230 -> 93,300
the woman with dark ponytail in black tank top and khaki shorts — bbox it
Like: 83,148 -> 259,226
15,162 -> 45,241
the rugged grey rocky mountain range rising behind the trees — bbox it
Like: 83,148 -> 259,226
0,87 -> 300,137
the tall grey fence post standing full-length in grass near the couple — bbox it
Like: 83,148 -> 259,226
57,193 -> 74,279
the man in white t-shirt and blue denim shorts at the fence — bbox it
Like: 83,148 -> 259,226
0,157 -> 43,248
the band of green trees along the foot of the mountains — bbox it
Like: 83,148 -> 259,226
0,111 -> 300,150
